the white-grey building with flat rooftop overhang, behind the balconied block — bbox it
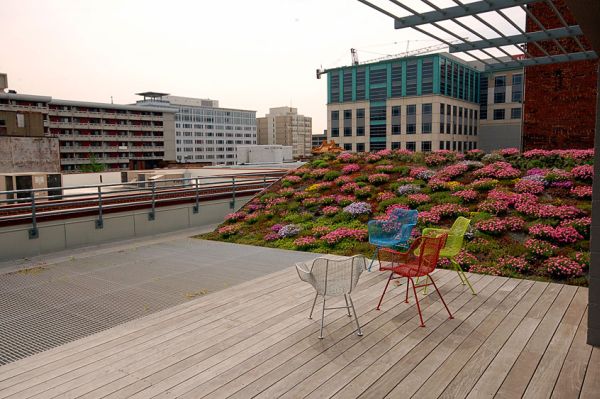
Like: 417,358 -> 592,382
137,92 -> 256,165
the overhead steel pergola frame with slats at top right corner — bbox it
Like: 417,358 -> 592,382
358,0 -> 598,71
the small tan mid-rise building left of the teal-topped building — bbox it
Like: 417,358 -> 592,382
257,107 -> 312,158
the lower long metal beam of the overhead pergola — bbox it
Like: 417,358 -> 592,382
450,25 -> 583,53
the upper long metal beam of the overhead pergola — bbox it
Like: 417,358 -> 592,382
394,0 -> 540,29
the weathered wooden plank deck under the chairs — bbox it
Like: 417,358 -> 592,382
0,268 -> 600,399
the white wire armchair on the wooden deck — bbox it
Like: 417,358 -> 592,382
296,255 -> 367,339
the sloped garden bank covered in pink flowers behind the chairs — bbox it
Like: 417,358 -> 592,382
202,149 -> 594,284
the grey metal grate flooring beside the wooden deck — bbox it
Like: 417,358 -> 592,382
0,239 -> 316,365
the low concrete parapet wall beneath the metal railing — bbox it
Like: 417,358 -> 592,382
0,197 -> 250,262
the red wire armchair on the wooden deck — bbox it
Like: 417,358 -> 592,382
377,234 -> 454,327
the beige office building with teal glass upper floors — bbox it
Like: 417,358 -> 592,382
325,54 -> 480,152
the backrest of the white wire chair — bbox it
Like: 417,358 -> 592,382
310,255 -> 367,295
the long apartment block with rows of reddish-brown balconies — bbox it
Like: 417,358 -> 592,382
0,92 -> 176,172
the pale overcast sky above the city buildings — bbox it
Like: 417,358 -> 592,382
0,0 -> 524,133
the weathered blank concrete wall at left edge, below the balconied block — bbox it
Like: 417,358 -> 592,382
0,137 -> 60,173
